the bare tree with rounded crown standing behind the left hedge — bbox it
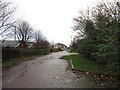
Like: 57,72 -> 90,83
14,21 -> 33,48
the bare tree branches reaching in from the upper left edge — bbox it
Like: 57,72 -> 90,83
0,0 -> 17,39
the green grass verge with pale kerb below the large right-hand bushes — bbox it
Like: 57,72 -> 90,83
61,54 -> 108,74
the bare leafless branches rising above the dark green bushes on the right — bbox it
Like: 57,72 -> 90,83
72,0 -> 120,38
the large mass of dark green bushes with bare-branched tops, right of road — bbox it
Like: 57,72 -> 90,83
73,1 -> 120,73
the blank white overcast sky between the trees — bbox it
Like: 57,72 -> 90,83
9,0 -> 109,45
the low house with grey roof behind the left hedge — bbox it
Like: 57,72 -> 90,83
2,40 -> 34,48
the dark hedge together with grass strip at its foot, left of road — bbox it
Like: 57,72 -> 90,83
0,48 -> 61,67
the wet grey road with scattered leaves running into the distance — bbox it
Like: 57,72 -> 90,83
3,51 -> 104,88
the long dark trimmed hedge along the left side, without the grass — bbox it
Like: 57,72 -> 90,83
2,48 -> 49,62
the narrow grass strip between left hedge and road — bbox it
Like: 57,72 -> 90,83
0,55 -> 41,67
